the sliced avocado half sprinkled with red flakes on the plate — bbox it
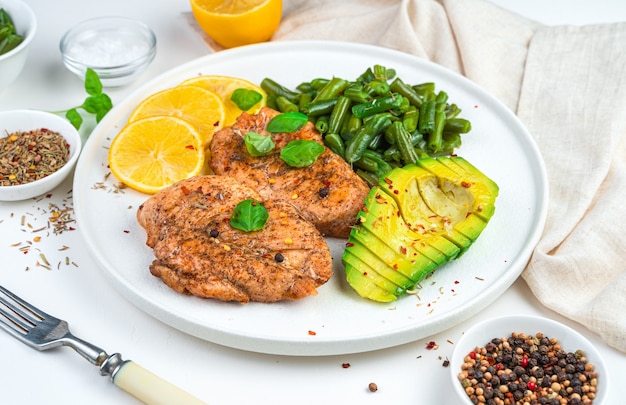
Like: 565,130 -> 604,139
342,156 -> 499,302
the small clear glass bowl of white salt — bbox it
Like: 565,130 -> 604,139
60,17 -> 156,87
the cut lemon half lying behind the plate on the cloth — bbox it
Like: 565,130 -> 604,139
191,0 -> 282,48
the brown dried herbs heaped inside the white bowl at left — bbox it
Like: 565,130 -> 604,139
0,128 -> 70,186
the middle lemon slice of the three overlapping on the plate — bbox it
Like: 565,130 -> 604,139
128,86 -> 225,145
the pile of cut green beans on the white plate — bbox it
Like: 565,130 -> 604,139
261,65 -> 471,185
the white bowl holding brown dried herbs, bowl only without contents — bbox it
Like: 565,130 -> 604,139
0,110 -> 82,201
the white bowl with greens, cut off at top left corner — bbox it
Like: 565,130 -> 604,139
0,0 -> 37,93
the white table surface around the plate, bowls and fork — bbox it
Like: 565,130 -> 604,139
0,0 -> 626,405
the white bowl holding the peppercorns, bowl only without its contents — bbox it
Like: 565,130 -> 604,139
449,315 -> 609,405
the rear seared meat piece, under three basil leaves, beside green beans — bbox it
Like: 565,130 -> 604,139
209,108 -> 369,238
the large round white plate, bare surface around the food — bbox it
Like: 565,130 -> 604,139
74,41 -> 547,356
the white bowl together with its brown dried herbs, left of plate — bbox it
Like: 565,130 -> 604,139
0,110 -> 82,201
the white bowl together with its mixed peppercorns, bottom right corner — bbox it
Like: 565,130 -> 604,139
450,315 -> 609,405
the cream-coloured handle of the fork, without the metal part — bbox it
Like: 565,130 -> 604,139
112,360 -> 206,405
